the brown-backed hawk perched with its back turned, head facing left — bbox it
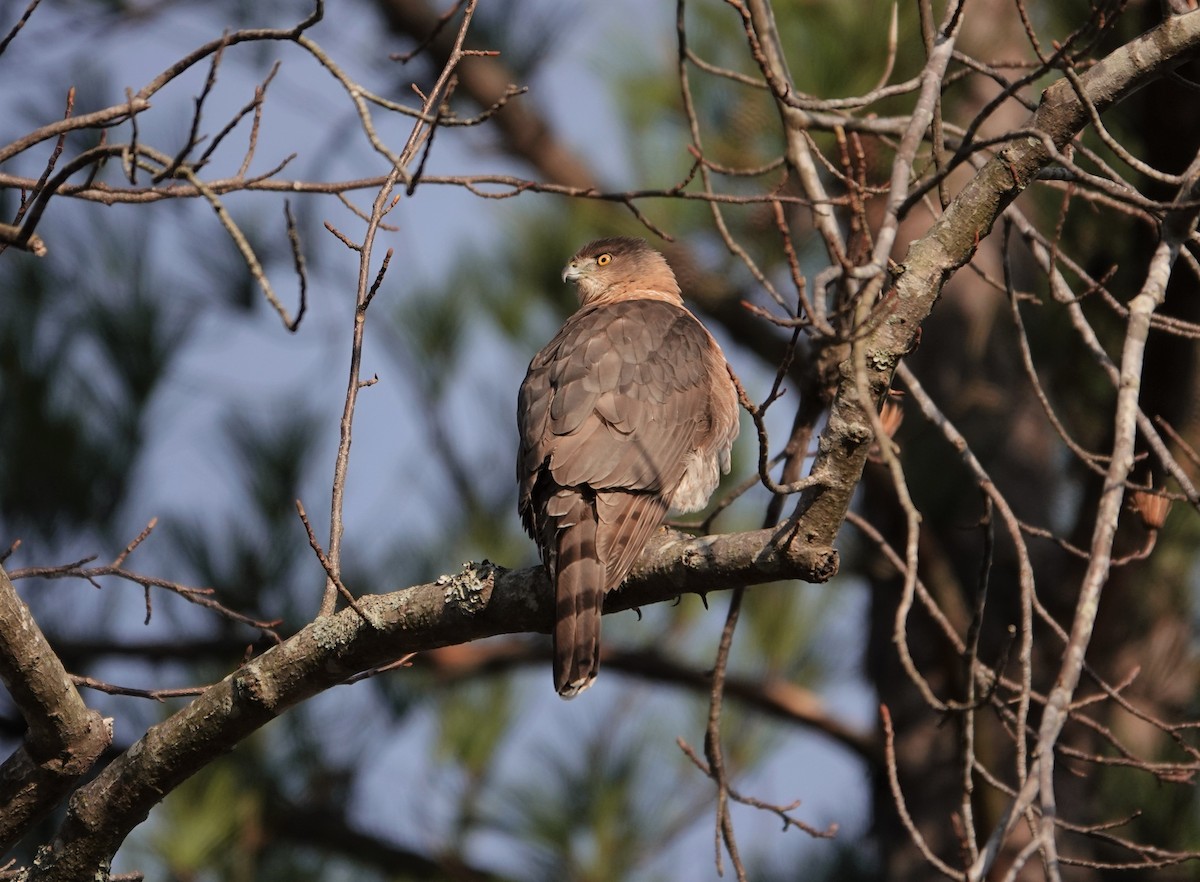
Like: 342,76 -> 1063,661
517,238 -> 738,698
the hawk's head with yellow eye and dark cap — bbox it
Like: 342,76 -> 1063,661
563,236 -> 683,306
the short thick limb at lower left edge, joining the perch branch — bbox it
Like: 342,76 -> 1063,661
0,569 -> 113,853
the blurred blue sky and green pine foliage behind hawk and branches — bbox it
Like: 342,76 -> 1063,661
0,0 -> 1200,882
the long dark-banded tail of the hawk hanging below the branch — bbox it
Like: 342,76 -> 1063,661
554,494 -> 605,698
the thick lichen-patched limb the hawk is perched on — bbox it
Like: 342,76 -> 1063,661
30,524 -> 838,882
